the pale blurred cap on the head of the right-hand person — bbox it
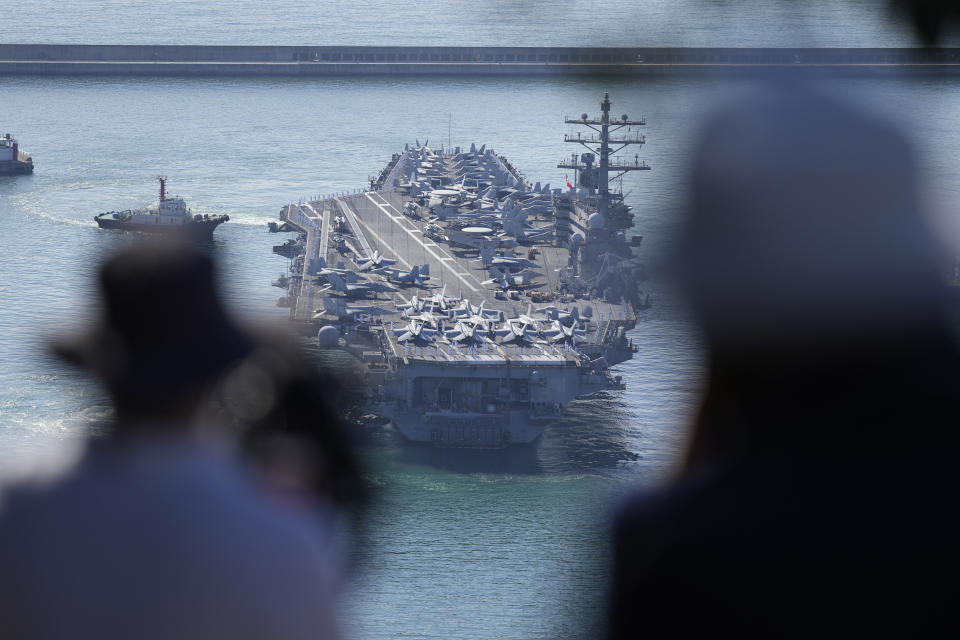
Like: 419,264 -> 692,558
678,81 -> 946,359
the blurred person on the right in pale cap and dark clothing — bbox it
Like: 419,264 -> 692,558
608,82 -> 960,639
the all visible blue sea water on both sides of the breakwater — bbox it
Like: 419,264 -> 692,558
0,6 -> 960,638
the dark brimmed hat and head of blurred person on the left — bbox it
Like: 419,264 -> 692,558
54,242 -> 251,427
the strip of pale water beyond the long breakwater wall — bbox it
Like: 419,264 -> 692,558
3,0 -> 944,47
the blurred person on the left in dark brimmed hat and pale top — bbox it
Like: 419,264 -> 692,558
0,243 -> 361,639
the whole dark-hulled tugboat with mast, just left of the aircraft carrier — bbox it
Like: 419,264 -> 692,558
93,176 -> 230,240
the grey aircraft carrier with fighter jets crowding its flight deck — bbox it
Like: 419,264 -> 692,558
270,95 -> 649,448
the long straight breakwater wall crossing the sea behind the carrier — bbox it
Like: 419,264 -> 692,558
0,44 -> 960,77
